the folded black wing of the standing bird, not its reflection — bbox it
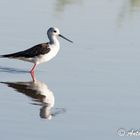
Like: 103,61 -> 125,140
2,43 -> 50,58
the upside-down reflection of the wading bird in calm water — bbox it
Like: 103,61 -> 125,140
1,75 -> 65,120
